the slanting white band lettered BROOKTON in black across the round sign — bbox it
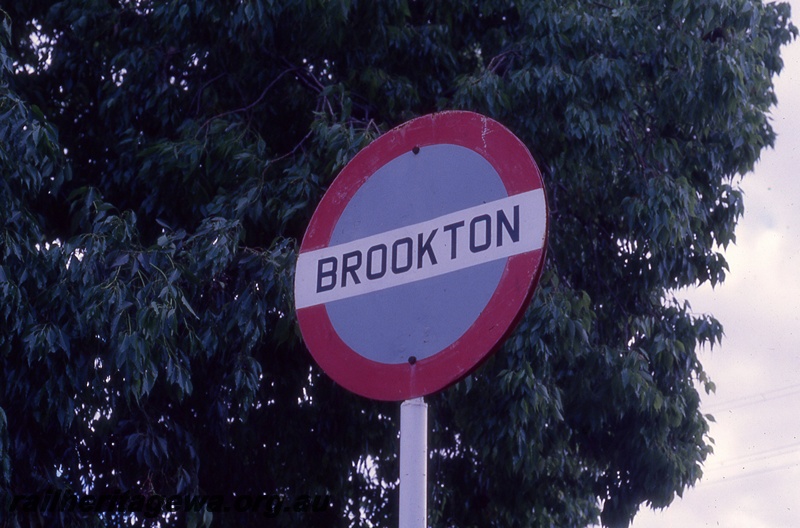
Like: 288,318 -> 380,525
295,189 -> 547,308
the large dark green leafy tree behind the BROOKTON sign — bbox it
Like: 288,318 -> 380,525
0,0 -> 797,528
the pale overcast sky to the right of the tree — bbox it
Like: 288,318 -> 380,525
633,0 -> 800,528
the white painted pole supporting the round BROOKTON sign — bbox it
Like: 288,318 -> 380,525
400,398 -> 428,528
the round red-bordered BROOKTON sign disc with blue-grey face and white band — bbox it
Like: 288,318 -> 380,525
295,111 -> 548,401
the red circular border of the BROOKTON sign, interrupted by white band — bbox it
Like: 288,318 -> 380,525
297,111 -> 549,401
